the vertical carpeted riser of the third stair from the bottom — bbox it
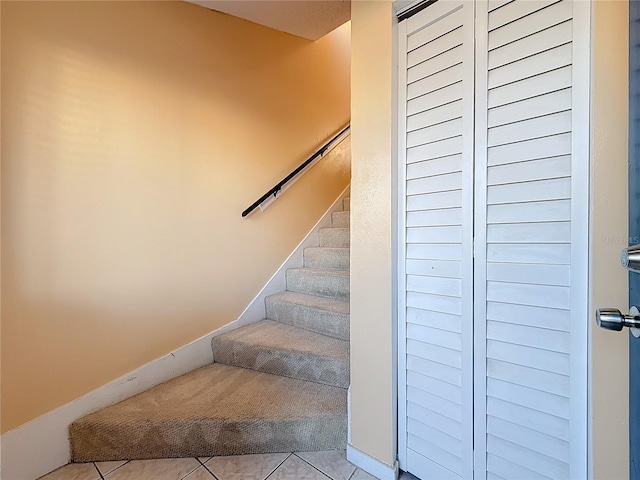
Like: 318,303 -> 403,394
266,297 -> 349,340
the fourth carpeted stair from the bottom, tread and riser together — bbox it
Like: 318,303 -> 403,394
287,268 -> 349,300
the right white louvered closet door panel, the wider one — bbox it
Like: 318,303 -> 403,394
475,0 -> 589,479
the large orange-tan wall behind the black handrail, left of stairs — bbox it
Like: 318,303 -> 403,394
1,1 -> 350,431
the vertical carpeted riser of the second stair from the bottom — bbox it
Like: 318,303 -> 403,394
212,337 -> 349,388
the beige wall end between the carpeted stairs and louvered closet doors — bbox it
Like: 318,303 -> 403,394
351,1 -> 395,465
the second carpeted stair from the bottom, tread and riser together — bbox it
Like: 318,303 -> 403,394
211,320 -> 349,388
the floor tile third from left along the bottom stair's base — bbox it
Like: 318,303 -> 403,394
204,453 -> 290,480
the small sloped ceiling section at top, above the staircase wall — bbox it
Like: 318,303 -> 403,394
187,0 -> 351,40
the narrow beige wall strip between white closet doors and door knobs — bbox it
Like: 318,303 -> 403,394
590,1 -> 629,480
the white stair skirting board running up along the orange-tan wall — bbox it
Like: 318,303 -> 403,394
0,187 -> 348,480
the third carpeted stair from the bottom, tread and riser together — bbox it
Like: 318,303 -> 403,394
266,292 -> 349,340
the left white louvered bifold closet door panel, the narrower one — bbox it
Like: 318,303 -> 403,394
399,1 -> 474,479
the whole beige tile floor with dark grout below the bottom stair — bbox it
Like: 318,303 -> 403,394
40,451 -> 415,480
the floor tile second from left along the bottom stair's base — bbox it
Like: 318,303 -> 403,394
106,458 -> 200,480
